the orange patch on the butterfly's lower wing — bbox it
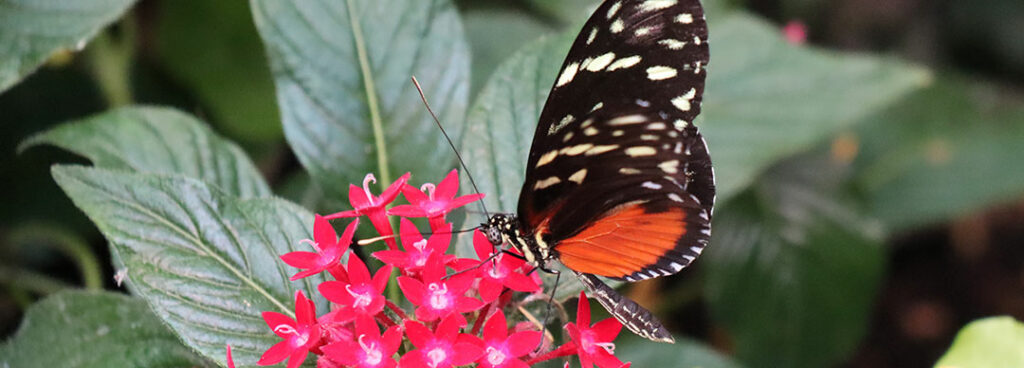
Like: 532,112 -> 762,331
555,205 -> 686,278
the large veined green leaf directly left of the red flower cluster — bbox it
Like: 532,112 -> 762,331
52,165 -> 327,365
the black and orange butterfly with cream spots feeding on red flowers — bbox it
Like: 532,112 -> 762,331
482,0 -> 715,342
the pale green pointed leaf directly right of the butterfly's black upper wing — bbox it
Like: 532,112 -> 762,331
698,11 -> 930,201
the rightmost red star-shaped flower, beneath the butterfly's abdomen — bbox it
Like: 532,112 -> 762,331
565,291 -> 624,368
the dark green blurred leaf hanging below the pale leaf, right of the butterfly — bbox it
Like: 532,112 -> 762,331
702,155 -> 885,367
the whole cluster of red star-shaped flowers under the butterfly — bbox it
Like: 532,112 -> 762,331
227,170 -> 629,368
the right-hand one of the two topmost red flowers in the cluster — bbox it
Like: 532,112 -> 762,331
388,170 -> 483,232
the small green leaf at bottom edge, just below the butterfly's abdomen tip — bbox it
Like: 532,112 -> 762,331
615,335 -> 741,368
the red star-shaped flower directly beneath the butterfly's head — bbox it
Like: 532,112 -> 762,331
473,230 -> 541,302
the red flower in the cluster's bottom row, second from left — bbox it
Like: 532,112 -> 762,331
324,316 -> 401,368
